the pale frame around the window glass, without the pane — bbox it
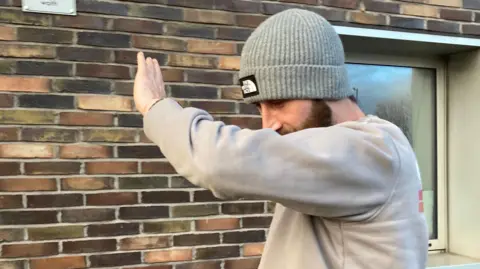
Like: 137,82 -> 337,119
346,53 -> 448,252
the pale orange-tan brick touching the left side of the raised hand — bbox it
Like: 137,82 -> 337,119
77,95 -> 133,111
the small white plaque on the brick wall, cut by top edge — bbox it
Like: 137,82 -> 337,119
22,0 -> 77,15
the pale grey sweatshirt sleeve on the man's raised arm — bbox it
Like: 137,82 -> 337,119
144,98 -> 399,217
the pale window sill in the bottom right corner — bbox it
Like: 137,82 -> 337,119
427,253 -> 480,269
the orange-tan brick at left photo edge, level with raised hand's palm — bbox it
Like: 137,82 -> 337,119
0,76 -> 50,92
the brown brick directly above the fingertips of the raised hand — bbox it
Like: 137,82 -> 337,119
132,35 -> 185,51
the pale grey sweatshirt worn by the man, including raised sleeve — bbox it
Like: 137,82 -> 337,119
144,99 -> 428,269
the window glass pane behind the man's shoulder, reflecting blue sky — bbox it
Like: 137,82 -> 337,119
347,64 -> 437,239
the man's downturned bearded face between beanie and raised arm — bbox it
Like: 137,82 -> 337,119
256,100 -> 332,135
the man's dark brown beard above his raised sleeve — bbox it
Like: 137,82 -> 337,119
277,100 -> 333,135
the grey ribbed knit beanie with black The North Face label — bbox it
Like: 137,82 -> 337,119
239,8 -> 353,103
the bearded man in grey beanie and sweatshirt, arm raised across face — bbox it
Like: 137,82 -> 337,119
134,9 -> 428,269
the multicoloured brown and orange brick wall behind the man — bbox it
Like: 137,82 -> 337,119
0,0 -> 480,269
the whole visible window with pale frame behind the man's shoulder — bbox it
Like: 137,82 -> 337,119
347,55 -> 446,250
